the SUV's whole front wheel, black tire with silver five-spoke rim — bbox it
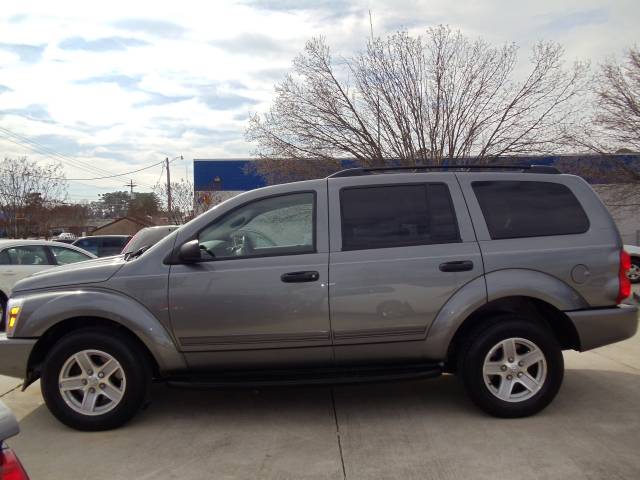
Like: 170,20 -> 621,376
41,329 -> 151,430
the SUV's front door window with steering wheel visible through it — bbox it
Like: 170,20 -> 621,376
198,193 -> 315,258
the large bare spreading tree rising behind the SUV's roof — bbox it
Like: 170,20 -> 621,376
247,26 -> 588,181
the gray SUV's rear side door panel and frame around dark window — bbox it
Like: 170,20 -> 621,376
329,173 -> 483,363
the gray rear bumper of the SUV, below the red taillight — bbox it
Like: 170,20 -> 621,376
565,305 -> 638,352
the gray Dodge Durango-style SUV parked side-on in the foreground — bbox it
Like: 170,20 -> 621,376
0,166 -> 637,430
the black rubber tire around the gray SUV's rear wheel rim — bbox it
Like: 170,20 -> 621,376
458,315 -> 564,418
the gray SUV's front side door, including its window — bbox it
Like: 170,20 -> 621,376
169,182 -> 332,370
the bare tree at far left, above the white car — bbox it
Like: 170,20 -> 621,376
0,157 -> 67,237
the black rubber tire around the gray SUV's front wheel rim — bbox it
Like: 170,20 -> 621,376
40,328 -> 152,431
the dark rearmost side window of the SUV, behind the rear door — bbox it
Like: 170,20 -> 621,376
472,181 -> 589,239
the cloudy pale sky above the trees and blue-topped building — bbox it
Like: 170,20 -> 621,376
0,0 -> 640,201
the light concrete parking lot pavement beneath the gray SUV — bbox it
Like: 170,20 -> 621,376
0,310 -> 640,480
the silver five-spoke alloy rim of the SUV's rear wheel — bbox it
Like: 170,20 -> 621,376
482,338 -> 547,403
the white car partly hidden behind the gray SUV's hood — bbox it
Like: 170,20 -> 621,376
0,240 -> 97,322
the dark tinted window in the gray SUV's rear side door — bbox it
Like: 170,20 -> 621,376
340,184 -> 459,250
